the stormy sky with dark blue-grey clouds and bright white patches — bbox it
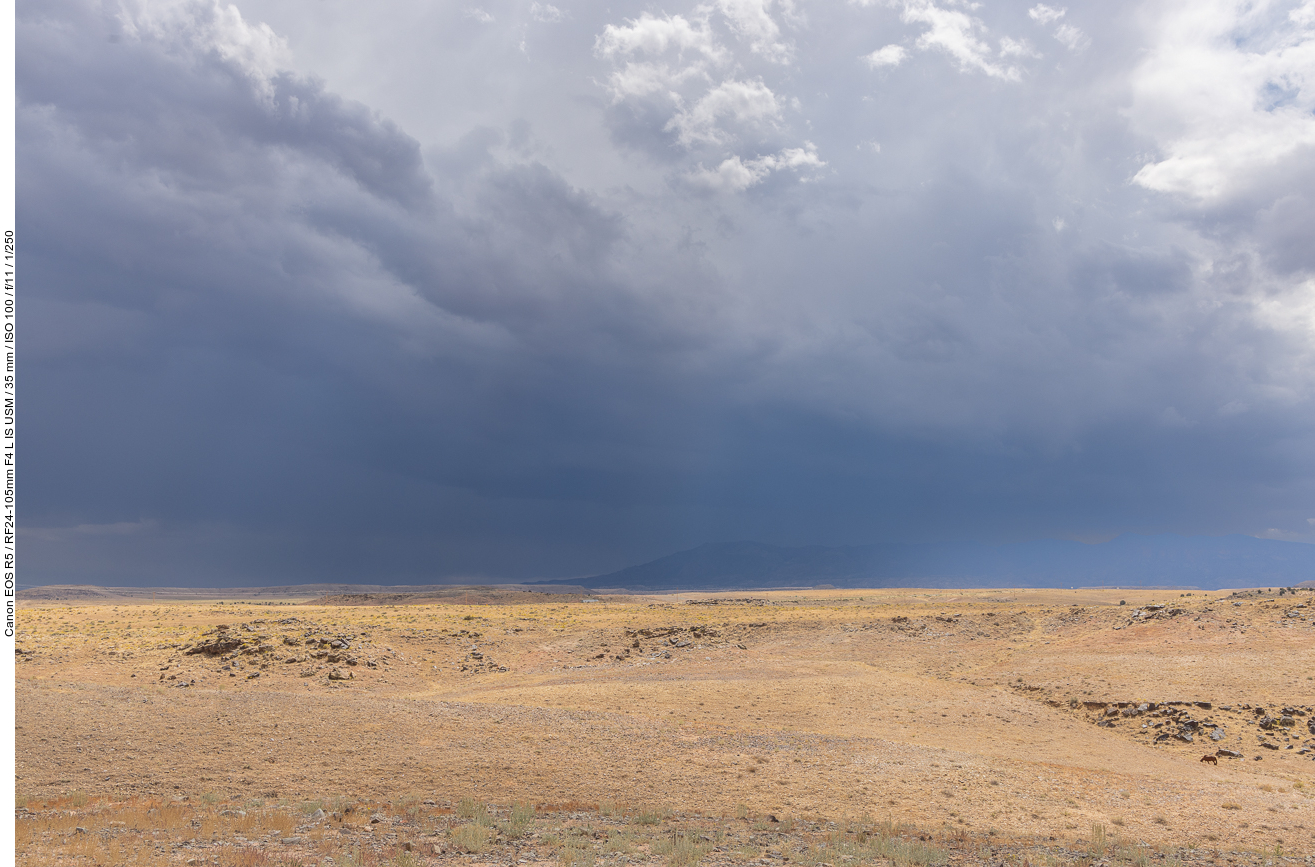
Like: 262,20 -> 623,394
17,0 -> 1315,584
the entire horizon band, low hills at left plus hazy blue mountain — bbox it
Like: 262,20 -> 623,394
18,534 -> 1315,603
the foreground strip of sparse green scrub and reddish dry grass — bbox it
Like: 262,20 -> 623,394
16,793 -> 1293,867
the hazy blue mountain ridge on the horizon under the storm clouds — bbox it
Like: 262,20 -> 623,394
557,533 -> 1315,591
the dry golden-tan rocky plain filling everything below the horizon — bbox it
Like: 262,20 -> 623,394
16,589 -> 1315,866
